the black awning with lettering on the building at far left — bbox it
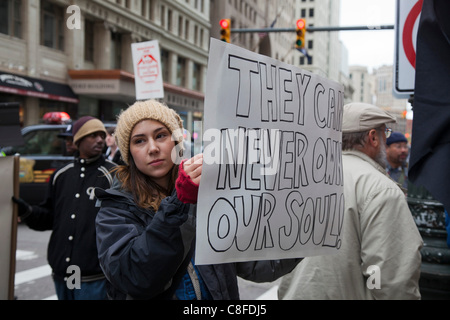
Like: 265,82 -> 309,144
0,72 -> 79,103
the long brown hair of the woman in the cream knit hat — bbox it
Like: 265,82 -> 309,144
114,156 -> 178,212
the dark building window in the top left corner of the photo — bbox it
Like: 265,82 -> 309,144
0,0 -> 22,38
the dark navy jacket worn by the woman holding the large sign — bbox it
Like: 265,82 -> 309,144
95,184 -> 301,300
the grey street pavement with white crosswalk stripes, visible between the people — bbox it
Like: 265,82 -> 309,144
14,224 -> 277,300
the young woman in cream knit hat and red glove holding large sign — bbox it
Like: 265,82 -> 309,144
96,100 -> 299,300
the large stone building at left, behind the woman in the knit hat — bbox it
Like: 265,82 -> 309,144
0,0 -> 211,129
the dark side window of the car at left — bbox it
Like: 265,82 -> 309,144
13,129 -> 65,156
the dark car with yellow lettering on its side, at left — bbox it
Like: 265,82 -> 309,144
1,123 -> 115,204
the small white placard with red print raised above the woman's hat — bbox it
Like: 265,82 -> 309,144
131,40 -> 164,100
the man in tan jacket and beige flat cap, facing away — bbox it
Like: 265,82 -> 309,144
278,103 -> 423,300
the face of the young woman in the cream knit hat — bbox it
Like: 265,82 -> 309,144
130,120 -> 175,188
